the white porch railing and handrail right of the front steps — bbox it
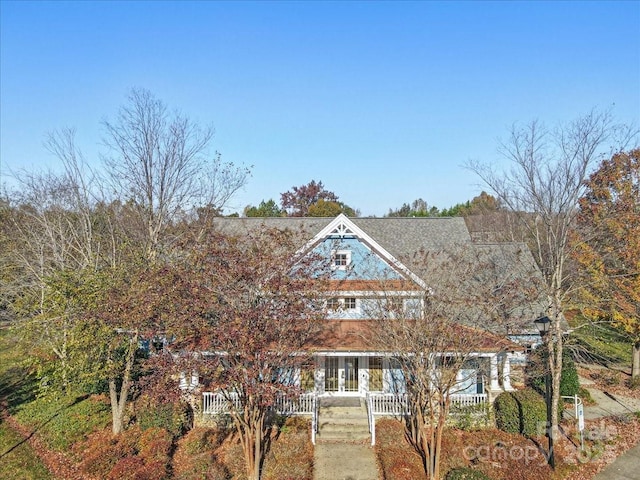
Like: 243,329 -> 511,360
367,393 -> 488,445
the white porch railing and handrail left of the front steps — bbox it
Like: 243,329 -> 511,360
202,392 -> 318,445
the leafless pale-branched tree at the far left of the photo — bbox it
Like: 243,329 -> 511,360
2,130 -> 116,390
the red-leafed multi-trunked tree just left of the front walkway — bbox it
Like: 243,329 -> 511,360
140,225 -> 330,480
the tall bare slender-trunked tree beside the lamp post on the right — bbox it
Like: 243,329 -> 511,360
467,111 -> 629,465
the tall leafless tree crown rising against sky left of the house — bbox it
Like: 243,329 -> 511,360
103,89 -> 249,258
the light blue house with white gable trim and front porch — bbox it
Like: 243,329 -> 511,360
194,214 -> 544,411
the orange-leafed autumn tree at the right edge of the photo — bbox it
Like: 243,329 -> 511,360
575,149 -> 640,378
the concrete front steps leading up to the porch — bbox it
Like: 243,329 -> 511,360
316,399 -> 371,443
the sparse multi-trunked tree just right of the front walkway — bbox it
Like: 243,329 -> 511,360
368,244 -> 538,480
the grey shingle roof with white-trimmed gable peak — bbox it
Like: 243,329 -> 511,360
215,214 -> 546,333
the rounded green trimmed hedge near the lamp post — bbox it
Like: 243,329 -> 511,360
493,388 -> 547,437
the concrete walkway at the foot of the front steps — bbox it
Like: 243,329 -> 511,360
313,442 -> 380,480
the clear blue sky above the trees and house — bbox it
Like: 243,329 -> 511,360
0,0 -> 640,216
